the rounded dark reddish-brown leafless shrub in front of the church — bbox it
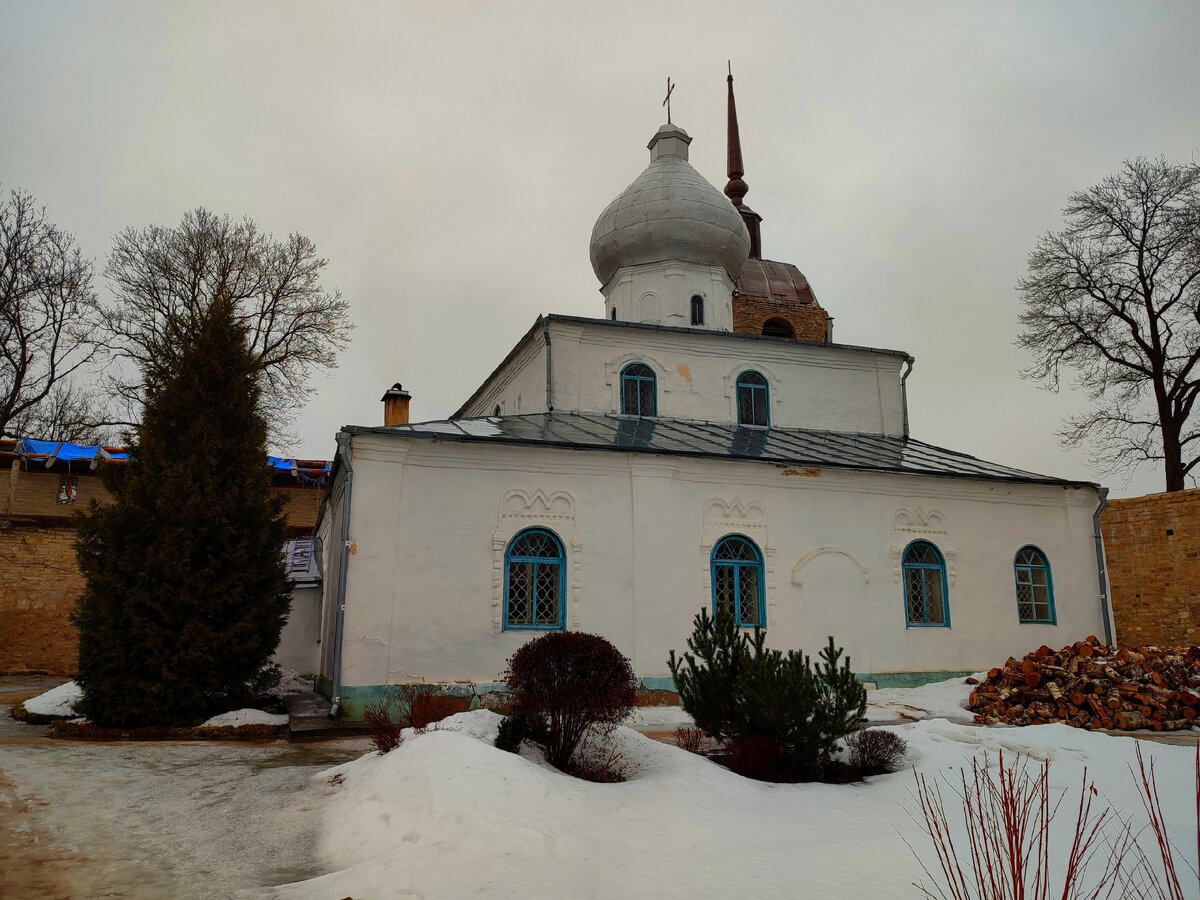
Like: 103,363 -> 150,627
502,631 -> 637,770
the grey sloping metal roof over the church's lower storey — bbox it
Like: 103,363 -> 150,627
344,412 -> 1094,487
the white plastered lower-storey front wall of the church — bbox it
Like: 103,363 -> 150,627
326,436 -> 1103,685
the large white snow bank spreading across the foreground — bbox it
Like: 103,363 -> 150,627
280,710 -> 1195,900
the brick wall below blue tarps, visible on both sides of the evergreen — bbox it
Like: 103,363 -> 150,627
0,463 -> 324,674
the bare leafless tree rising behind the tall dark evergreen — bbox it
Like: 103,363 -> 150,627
103,209 -> 353,436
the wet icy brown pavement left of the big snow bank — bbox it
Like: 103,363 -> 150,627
0,676 -> 370,900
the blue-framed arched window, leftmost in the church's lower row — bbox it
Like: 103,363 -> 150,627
504,528 -> 566,629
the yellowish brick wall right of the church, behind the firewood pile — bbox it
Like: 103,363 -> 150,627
1100,488 -> 1200,647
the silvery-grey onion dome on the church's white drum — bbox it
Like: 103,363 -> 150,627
592,124 -> 750,284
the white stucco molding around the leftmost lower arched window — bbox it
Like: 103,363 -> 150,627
492,487 -> 583,634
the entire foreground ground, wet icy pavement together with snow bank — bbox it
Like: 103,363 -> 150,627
0,679 -> 1198,900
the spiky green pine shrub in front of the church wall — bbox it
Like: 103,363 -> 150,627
667,610 -> 866,778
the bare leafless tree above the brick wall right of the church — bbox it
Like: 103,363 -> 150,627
1018,157 -> 1200,491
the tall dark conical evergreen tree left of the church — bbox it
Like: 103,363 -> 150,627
73,299 -> 289,727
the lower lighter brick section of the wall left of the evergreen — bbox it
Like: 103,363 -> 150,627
0,520 -> 83,674
